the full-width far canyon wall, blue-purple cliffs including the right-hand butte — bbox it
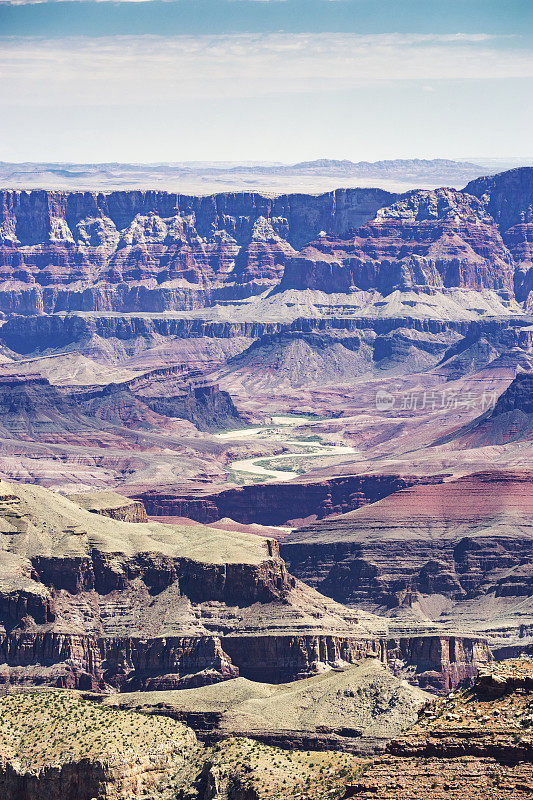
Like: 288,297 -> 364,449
0,168 -> 533,315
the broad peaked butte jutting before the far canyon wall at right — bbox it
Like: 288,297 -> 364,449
280,189 -> 514,295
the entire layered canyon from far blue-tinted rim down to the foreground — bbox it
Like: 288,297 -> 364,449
0,165 -> 533,800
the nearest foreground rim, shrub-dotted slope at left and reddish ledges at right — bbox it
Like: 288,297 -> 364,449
0,660 -> 533,800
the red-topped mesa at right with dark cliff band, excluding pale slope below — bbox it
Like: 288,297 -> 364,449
281,472 -> 533,607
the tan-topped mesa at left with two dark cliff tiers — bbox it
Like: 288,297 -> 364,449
0,484 -> 302,688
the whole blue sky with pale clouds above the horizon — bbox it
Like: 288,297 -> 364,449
0,0 -> 533,163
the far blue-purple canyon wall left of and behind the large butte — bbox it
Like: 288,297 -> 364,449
0,189 -> 394,314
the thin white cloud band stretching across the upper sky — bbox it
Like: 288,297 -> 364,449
0,33 -> 533,105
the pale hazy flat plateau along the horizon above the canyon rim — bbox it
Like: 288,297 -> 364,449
0,158 -> 516,194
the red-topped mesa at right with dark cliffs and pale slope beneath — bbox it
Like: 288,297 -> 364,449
281,472 -> 533,647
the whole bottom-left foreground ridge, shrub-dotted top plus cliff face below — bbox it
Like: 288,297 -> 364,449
0,690 -> 363,800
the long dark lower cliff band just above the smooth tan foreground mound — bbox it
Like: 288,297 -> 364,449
0,632 -> 491,694
